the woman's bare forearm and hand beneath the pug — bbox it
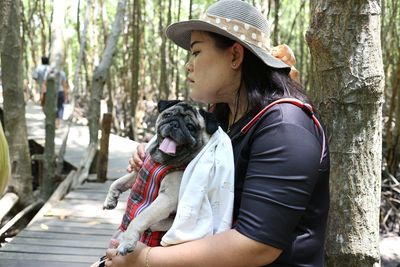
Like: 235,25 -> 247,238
106,230 -> 282,267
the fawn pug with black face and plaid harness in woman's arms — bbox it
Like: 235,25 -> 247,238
103,100 -> 218,255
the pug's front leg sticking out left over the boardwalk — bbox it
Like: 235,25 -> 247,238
103,172 -> 136,210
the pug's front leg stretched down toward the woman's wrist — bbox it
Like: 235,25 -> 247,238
118,171 -> 182,255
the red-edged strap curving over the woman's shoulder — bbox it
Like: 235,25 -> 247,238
241,98 -> 326,162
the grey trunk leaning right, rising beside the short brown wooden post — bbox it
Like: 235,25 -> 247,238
88,0 -> 126,144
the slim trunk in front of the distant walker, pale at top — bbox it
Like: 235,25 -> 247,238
41,0 -> 66,200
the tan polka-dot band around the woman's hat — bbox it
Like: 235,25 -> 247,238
201,13 -> 271,53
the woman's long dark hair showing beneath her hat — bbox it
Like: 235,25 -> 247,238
207,32 -> 310,123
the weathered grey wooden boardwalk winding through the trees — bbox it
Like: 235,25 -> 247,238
0,102 -> 136,267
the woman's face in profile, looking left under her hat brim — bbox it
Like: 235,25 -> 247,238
186,31 -> 240,104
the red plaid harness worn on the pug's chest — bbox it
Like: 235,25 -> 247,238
119,155 -> 186,247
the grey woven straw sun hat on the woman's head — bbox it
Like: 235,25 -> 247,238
165,0 -> 290,72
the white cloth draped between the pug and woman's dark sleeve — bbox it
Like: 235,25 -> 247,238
161,127 -> 235,246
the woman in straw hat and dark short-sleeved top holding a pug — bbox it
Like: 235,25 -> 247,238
101,0 -> 329,267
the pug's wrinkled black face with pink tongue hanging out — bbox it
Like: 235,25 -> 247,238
150,102 -> 217,166
